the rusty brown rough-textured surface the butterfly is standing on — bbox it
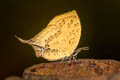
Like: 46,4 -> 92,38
23,59 -> 120,80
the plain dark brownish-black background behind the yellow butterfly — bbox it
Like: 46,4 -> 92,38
0,0 -> 120,79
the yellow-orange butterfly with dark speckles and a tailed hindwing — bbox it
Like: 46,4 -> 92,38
16,10 -> 88,61
